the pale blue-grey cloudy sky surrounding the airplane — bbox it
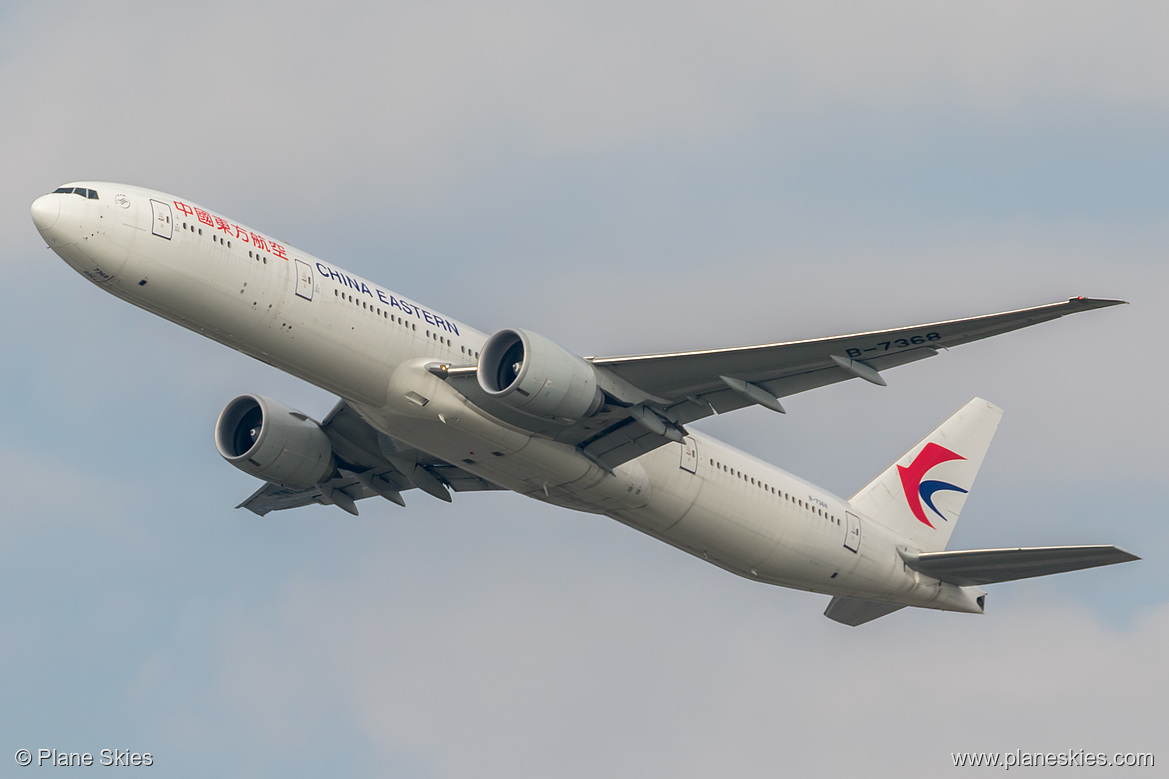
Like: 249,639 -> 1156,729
0,0 -> 1169,779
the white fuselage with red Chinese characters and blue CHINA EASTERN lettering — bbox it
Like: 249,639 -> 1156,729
34,182 -> 981,612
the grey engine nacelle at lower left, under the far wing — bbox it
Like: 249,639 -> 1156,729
215,395 -> 333,490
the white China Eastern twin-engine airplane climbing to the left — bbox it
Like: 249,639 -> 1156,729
32,181 -> 1140,626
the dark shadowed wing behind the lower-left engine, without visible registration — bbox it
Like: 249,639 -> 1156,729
236,400 -> 503,516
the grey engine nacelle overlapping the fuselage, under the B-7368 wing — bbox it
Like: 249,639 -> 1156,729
478,330 -> 604,420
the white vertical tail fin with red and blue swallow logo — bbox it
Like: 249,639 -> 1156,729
850,398 -> 1003,552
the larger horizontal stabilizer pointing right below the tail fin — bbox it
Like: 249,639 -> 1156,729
898,545 -> 1141,587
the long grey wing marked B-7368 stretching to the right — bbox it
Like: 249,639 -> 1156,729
440,297 -> 1125,469
